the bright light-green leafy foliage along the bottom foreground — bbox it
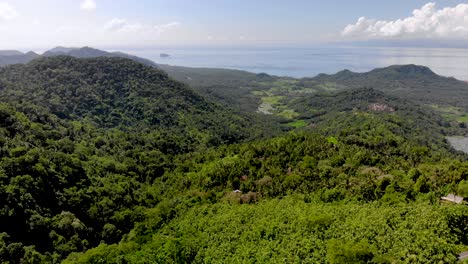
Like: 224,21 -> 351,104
66,199 -> 468,263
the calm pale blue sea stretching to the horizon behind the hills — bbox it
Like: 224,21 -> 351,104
126,47 -> 468,80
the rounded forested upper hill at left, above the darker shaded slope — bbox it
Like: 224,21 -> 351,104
0,56 -> 278,151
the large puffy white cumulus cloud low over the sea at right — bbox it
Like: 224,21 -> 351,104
342,2 -> 468,39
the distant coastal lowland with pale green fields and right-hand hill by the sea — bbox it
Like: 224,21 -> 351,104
159,65 -> 468,125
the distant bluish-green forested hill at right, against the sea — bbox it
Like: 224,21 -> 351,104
305,65 -> 468,109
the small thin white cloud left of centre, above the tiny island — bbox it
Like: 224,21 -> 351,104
104,18 -> 180,34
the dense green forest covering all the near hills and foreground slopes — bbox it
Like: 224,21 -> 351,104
0,56 -> 468,263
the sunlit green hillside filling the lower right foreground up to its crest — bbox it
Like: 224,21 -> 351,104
65,90 -> 468,263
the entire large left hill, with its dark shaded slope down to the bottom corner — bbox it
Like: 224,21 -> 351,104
0,56 -> 279,262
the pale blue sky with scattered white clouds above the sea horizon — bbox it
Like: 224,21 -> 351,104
0,0 -> 468,51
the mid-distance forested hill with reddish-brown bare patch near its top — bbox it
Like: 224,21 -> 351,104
290,88 -> 458,148
